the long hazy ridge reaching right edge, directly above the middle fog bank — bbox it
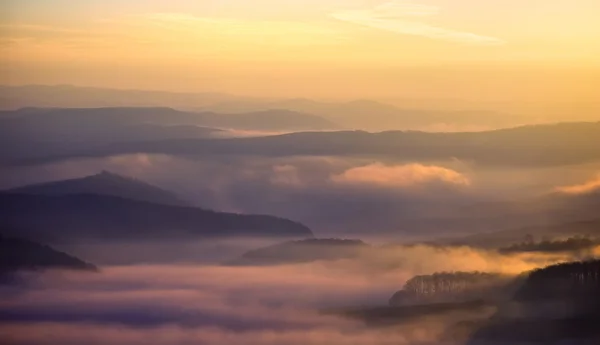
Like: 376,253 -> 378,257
14,122 -> 600,167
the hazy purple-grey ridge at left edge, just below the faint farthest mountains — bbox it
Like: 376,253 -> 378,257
0,108 -> 221,163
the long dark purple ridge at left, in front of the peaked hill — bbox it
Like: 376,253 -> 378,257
0,193 -> 312,243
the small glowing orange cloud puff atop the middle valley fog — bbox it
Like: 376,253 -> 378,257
331,163 -> 470,187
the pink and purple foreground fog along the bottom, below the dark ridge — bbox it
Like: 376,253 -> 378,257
0,242 -> 592,345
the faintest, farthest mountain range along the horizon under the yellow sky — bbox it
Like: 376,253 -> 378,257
0,85 -> 520,131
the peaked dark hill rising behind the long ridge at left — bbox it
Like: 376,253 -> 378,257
6,171 -> 190,206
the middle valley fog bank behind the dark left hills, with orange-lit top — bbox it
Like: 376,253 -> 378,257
0,154 -> 600,240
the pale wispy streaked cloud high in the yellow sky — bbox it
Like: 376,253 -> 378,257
331,1 -> 504,45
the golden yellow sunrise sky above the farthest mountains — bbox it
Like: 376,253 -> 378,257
0,0 -> 600,100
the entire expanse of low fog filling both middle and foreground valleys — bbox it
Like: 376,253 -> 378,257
0,146 -> 600,345
